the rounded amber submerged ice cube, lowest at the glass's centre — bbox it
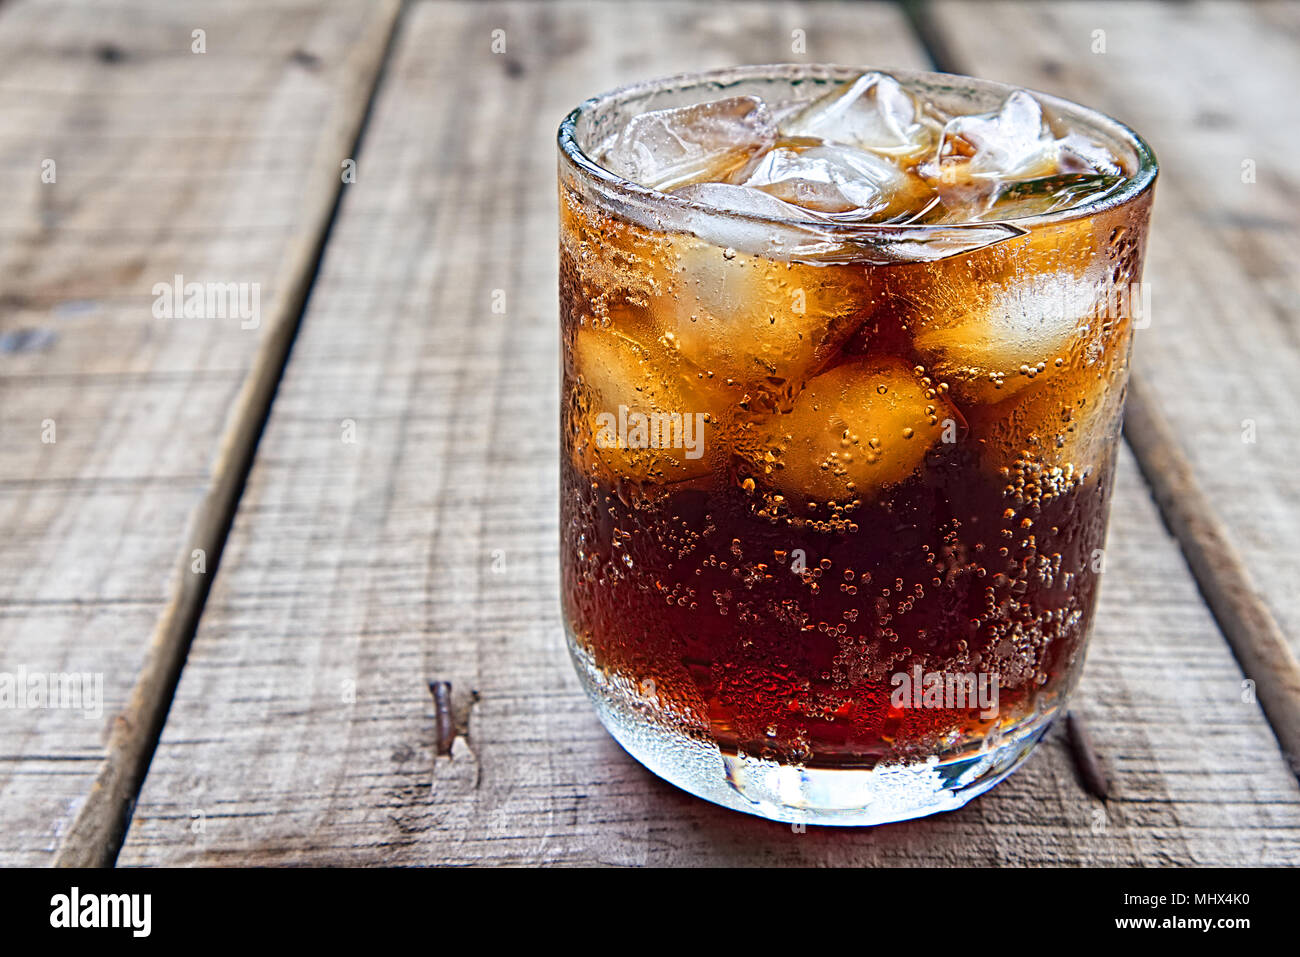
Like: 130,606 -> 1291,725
745,356 -> 953,511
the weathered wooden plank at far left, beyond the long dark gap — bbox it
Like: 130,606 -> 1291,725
0,0 -> 395,865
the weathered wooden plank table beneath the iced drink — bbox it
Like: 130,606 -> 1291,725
0,0 -> 1300,865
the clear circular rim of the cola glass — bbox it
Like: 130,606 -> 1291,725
556,64 -> 1160,242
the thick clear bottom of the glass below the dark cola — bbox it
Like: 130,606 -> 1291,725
568,636 -> 1057,827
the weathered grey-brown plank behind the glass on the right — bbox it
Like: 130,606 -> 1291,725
933,1 -> 1300,770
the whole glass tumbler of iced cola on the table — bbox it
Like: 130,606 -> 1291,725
560,66 -> 1156,824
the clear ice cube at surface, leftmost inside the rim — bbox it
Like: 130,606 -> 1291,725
602,96 -> 776,190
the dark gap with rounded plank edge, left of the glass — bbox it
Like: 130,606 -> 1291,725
55,0 -> 404,867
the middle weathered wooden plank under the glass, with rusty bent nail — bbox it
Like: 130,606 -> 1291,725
118,3 -> 1300,865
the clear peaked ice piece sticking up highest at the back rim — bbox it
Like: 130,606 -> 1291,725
781,73 -> 937,160
